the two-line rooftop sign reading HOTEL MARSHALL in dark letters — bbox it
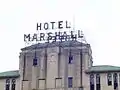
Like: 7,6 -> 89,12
24,21 -> 83,43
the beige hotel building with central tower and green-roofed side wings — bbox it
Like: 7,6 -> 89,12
0,41 -> 120,90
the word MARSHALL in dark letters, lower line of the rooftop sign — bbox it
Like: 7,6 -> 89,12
24,30 -> 83,43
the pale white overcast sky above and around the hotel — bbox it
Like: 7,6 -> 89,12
0,0 -> 120,72
